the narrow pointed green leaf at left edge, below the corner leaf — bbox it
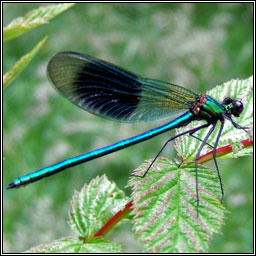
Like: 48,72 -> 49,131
3,36 -> 47,87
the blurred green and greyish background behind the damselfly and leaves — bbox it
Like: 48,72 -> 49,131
3,3 -> 253,253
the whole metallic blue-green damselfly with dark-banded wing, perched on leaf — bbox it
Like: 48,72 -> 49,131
7,52 -> 247,214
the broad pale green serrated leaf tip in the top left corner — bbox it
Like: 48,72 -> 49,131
3,3 -> 74,42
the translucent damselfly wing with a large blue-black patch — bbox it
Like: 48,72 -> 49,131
47,52 -> 197,122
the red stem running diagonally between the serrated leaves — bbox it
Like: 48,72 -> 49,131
94,139 -> 253,237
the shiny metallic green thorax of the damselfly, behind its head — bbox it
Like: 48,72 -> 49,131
197,95 -> 225,121
